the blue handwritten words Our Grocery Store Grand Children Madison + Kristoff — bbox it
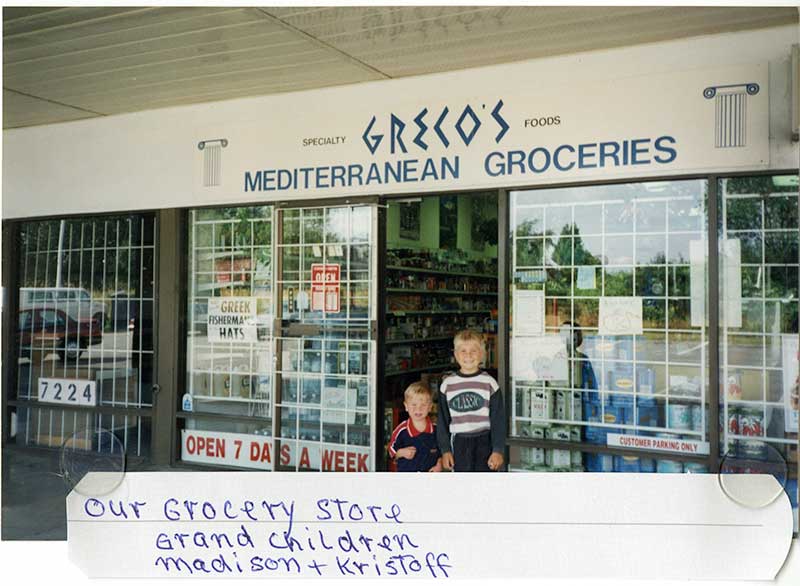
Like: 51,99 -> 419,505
83,497 -> 452,578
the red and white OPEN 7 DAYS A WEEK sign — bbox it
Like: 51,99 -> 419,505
181,429 -> 372,472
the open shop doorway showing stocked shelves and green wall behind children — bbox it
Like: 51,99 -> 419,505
381,192 -> 499,469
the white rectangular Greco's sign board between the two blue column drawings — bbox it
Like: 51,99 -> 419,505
203,65 -> 769,197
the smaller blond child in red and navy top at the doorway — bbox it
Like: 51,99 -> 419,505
389,382 -> 442,472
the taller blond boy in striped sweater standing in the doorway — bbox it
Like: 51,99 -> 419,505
436,330 -> 506,472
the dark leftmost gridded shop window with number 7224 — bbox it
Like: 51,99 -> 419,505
11,214 -> 156,456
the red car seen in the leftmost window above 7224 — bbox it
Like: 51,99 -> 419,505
17,308 -> 103,361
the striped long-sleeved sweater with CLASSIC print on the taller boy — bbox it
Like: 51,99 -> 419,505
436,370 -> 506,454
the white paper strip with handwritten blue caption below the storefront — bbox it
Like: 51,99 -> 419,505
67,472 -> 792,580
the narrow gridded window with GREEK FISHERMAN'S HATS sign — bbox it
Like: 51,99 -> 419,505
182,206 -> 273,455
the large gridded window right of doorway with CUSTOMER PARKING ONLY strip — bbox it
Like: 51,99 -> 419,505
509,180 -> 710,471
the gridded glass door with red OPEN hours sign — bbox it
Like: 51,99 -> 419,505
274,205 -> 377,472
